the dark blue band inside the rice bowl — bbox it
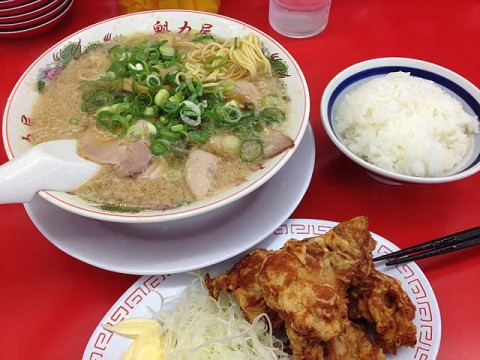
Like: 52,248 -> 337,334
327,66 -> 480,179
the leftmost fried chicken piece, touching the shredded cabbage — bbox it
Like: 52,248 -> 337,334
205,249 -> 283,329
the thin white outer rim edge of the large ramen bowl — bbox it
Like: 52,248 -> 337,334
2,9 -> 310,223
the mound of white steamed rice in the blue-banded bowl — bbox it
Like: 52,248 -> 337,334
334,72 -> 479,177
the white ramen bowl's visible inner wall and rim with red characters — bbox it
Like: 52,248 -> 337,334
3,10 -> 310,223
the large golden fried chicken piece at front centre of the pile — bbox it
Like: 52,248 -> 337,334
257,236 -> 347,340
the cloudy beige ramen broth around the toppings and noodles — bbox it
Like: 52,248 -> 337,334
30,31 -> 293,211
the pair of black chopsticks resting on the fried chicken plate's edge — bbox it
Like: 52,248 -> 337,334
373,226 -> 480,265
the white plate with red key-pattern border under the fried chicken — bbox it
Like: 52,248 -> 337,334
83,219 -> 442,360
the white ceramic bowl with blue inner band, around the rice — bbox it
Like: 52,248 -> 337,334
320,58 -> 480,185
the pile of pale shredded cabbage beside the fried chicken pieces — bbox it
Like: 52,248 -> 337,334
155,277 -> 291,360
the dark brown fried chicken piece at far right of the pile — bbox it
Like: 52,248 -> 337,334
349,270 -> 417,354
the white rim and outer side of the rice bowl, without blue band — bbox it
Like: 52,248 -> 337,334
320,57 -> 480,184
